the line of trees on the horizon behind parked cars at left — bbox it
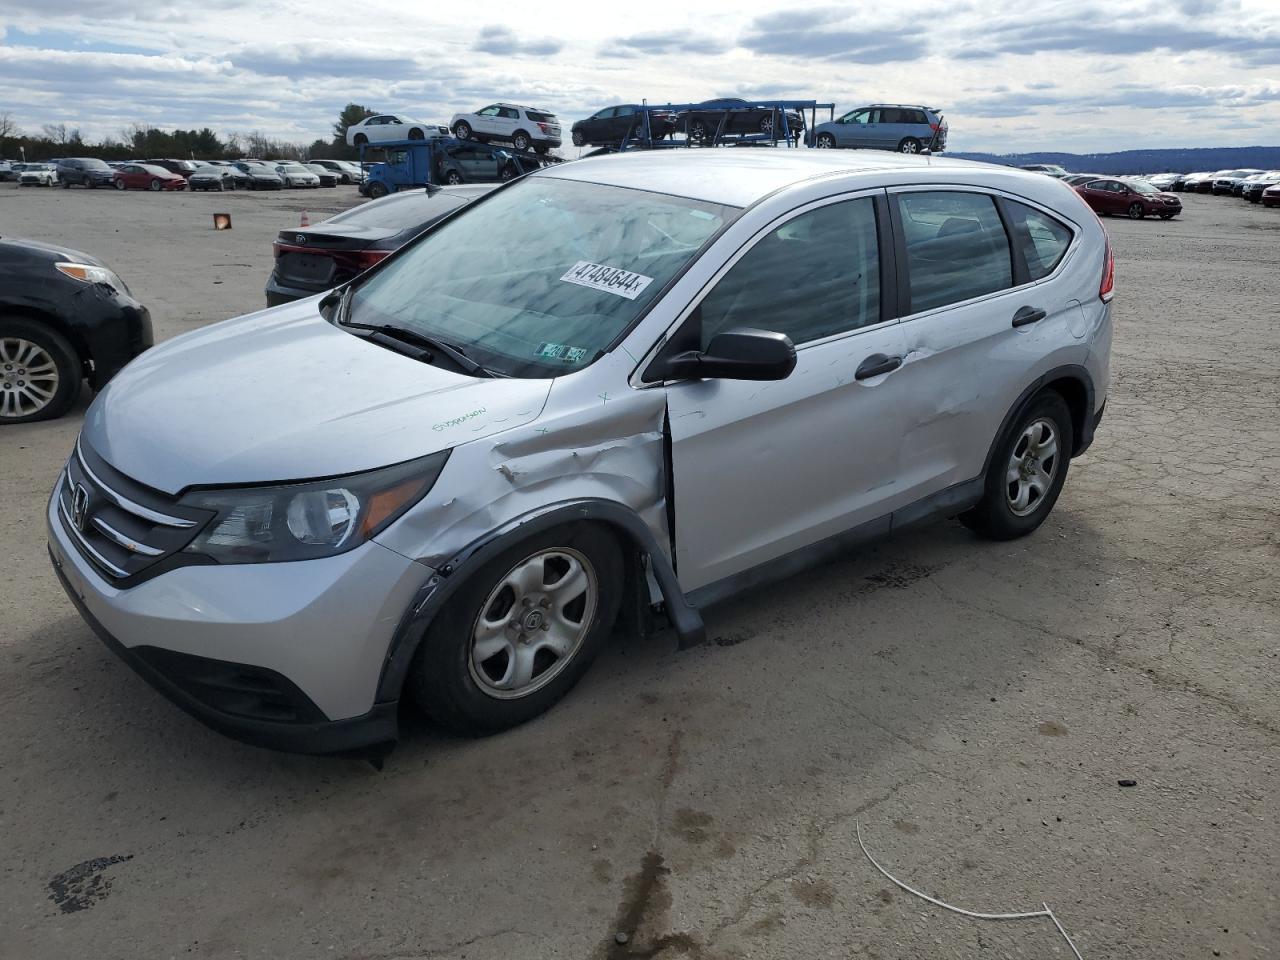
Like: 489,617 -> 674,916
0,104 -> 375,161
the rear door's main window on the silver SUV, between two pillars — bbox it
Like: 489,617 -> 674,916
896,191 -> 1014,314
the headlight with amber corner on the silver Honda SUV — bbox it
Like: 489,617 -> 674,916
182,451 -> 449,563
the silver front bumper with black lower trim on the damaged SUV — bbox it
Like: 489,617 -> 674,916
46,499 -> 433,753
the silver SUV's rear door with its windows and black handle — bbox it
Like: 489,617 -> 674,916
890,187 -> 1083,500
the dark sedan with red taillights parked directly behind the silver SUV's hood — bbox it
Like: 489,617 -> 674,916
266,184 -> 494,307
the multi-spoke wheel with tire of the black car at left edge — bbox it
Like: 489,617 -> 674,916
0,317 -> 84,424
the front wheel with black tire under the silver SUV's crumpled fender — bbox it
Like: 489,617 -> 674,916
407,524 -> 623,736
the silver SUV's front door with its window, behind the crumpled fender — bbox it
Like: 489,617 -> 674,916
667,192 -> 905,590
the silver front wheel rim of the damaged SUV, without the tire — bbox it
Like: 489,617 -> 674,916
467,547 -> 600,700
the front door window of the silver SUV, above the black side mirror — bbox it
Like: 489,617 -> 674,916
699,197 -> 881,347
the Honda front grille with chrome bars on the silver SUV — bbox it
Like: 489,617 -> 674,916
56,442 -> 212,586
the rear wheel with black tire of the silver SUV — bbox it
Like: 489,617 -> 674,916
960,390 -> 1075,540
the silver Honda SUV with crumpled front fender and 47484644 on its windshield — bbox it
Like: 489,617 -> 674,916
47,150 -> 1112,751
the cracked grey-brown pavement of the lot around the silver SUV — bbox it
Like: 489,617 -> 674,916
0,189 -> 1280,960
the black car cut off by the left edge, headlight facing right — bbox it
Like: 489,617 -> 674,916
0,239 -> 152,424
